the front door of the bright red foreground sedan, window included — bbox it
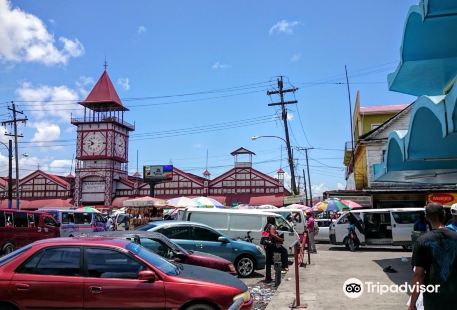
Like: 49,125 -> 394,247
84,247 -> 165,309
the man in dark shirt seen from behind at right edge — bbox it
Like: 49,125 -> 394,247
409,202 -> 457,310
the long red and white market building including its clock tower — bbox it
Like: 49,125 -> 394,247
0,70 -> 290,209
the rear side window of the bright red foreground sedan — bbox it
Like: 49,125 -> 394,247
17,247 -> 81,276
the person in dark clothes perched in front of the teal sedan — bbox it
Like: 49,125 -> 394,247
261,216 -> 289,283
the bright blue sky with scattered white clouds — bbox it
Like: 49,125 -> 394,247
0,0 -> 419,195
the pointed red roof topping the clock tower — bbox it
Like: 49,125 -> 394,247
80,70 -> 128,111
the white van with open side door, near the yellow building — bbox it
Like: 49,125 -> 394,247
330,208 -> 424,249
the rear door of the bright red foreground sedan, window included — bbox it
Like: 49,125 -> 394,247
10,246 -> 83,309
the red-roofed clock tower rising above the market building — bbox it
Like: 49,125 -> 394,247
71,69 -> 135,206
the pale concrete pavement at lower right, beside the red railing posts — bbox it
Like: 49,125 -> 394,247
266,244 -> 412,310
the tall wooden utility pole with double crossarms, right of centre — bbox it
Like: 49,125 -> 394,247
267,76 -> 298,195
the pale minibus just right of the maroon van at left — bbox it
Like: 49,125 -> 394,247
39,209 -> 106,237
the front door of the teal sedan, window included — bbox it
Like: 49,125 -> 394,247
193,226 -> 233,261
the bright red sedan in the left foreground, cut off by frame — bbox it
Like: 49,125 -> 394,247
0,237 -> 252,310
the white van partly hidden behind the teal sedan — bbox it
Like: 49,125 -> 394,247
178,208 -> 299,254
